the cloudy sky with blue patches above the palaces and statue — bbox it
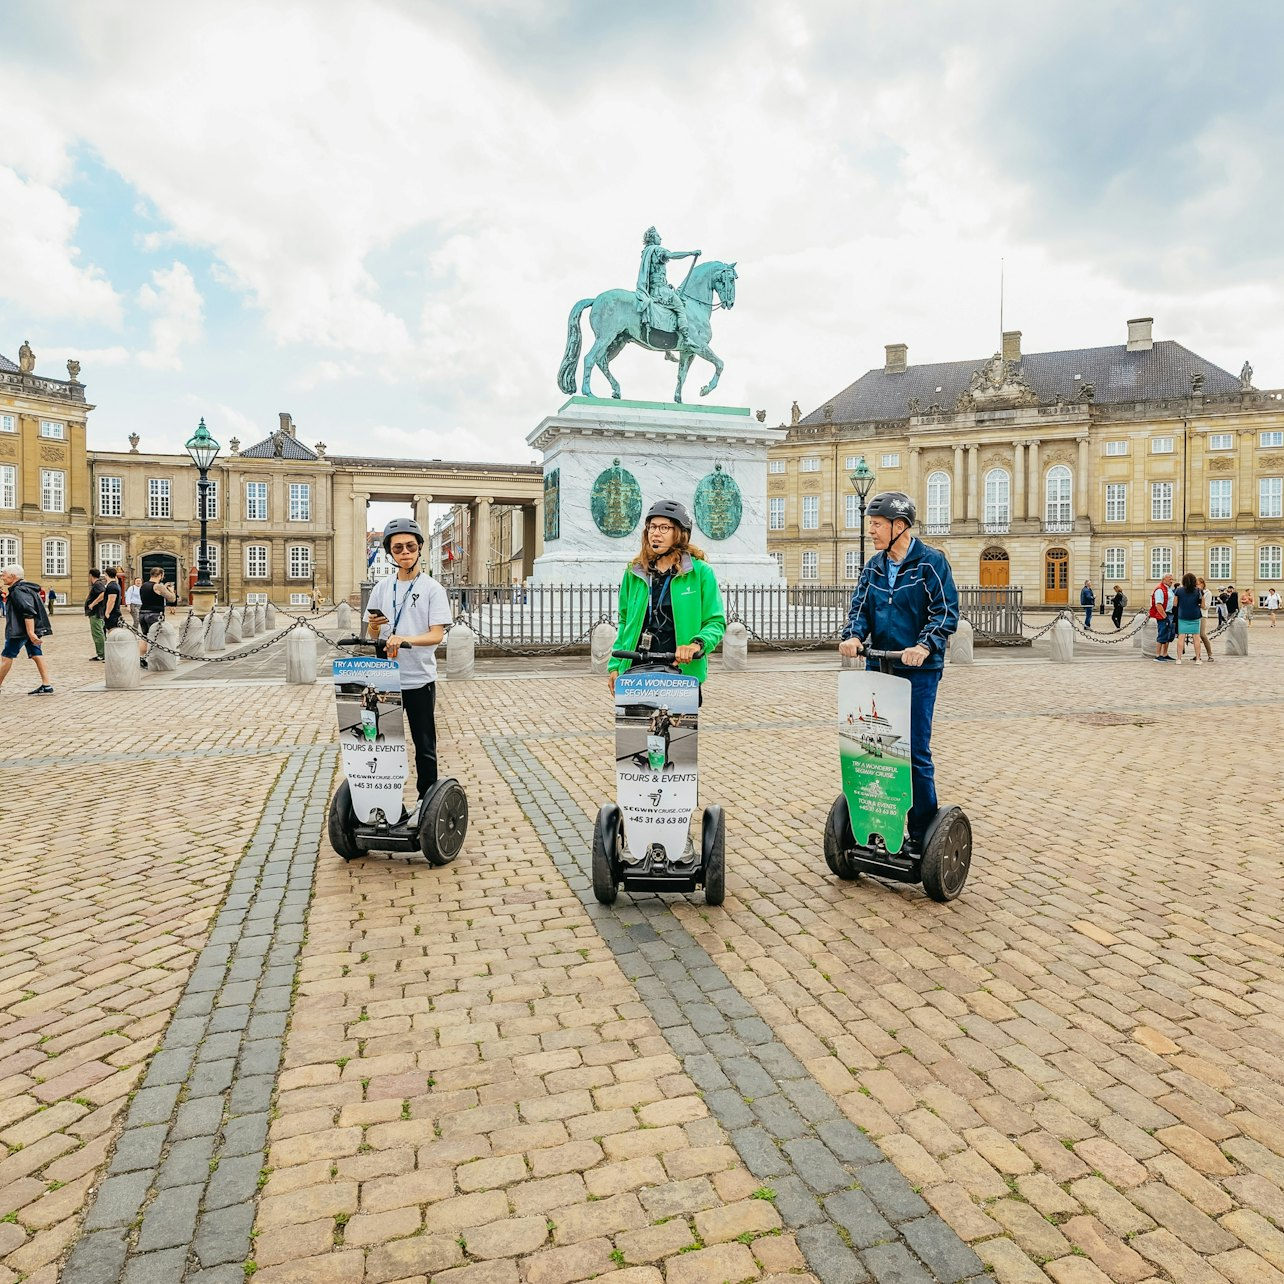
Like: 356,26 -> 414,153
0,0 -> 1284,462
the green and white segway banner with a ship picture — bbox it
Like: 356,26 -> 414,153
838,669 -> 914,853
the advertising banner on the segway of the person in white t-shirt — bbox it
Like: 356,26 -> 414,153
334,657 -> 408,824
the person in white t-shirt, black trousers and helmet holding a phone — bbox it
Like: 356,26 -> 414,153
365,517 -> 451,800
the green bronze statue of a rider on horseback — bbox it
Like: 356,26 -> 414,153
557,227 -> 737,402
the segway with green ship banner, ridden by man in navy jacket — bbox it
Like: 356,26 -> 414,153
824,647 -> 972,903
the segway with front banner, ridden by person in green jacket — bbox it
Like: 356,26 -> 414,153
593,651 -> 727,905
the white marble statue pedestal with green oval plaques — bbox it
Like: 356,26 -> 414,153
526,397 -> 785,584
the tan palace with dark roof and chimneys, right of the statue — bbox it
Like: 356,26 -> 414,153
768,317 -> 1284,606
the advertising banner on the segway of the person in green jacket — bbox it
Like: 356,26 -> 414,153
615,673 -> 700,865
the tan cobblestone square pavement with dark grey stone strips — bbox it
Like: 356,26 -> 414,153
0,620 -> 1284,1284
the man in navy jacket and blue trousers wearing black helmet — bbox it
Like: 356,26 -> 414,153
838,490 -> 959,853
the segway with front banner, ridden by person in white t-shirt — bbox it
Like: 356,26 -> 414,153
327,637 -> 469,865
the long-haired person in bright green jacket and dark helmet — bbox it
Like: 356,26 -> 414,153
607,499 -> 727,691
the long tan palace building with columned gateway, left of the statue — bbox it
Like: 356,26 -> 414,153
0,343 -> 543,606
